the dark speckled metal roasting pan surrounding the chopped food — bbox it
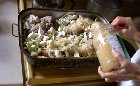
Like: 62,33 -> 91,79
18,8 -> 132,68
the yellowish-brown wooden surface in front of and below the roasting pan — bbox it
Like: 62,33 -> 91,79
24,53 -> 116,86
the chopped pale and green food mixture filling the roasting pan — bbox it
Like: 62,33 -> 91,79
24,13 -> 96,58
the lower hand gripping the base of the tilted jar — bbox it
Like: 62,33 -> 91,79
98,51 -> 140,82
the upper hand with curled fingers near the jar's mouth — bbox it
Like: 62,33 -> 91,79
111,16 -> 140,42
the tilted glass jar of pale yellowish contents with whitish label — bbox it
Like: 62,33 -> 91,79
91,22 -> 129,72
